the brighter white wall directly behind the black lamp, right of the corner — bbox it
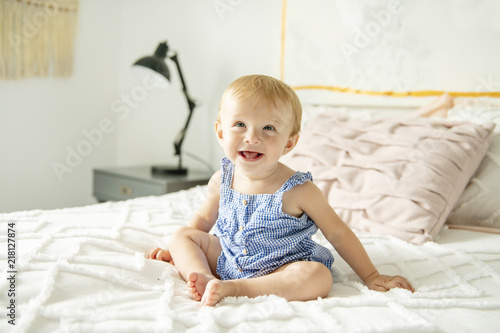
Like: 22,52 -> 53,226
117,0 -> 281,169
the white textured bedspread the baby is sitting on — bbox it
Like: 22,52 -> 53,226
0,187 -> 500,333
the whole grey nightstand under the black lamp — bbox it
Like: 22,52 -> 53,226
93,166 -> 211,202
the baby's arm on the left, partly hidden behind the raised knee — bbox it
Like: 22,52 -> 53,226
147,170 -> 220,265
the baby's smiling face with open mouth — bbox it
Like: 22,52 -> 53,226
215,96 -> 298,176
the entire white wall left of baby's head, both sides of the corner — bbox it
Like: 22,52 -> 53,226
0,0 -> 281,212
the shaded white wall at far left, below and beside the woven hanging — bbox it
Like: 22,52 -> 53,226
0,0 -> 120,212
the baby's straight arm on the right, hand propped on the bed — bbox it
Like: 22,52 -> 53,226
294,182 -> 414,292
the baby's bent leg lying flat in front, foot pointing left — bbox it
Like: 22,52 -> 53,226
201,261 -> 333,306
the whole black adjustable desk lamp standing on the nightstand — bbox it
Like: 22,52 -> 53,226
134,42 -> 196,175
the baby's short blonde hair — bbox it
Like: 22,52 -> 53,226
217,74 -> 302,136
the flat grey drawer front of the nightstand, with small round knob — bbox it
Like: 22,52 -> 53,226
94,173 -> 166,201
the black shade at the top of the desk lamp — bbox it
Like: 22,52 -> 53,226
133,42 -> 170,88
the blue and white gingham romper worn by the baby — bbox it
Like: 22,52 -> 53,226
215,157 -> 333,280
